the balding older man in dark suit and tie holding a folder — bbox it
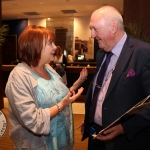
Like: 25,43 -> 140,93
81,6 -> 150,150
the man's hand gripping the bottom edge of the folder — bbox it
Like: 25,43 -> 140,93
92,124 -> 124,141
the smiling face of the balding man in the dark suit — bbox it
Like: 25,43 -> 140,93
89,17 -> 113,52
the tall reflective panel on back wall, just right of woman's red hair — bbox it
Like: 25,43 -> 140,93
46,17 -> 74,56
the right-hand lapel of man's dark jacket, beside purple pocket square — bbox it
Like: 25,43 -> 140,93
105,37 -> 134,98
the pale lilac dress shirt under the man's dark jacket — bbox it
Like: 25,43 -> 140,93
93,33 -> 127,126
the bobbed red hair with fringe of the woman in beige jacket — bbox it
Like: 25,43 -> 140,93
18,25 -> 55,67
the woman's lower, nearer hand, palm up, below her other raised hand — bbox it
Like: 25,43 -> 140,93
60,87 -> 84,107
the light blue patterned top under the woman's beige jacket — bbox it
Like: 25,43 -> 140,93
32,67 -> 74,150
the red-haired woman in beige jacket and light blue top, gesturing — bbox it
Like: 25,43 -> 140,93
5,25 -> 87,150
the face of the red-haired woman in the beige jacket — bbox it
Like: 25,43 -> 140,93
40,42 -> 57,64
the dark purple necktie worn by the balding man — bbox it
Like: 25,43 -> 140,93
89,52 -> 113,123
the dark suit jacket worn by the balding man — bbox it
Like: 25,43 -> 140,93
82,36 -> 150,150
